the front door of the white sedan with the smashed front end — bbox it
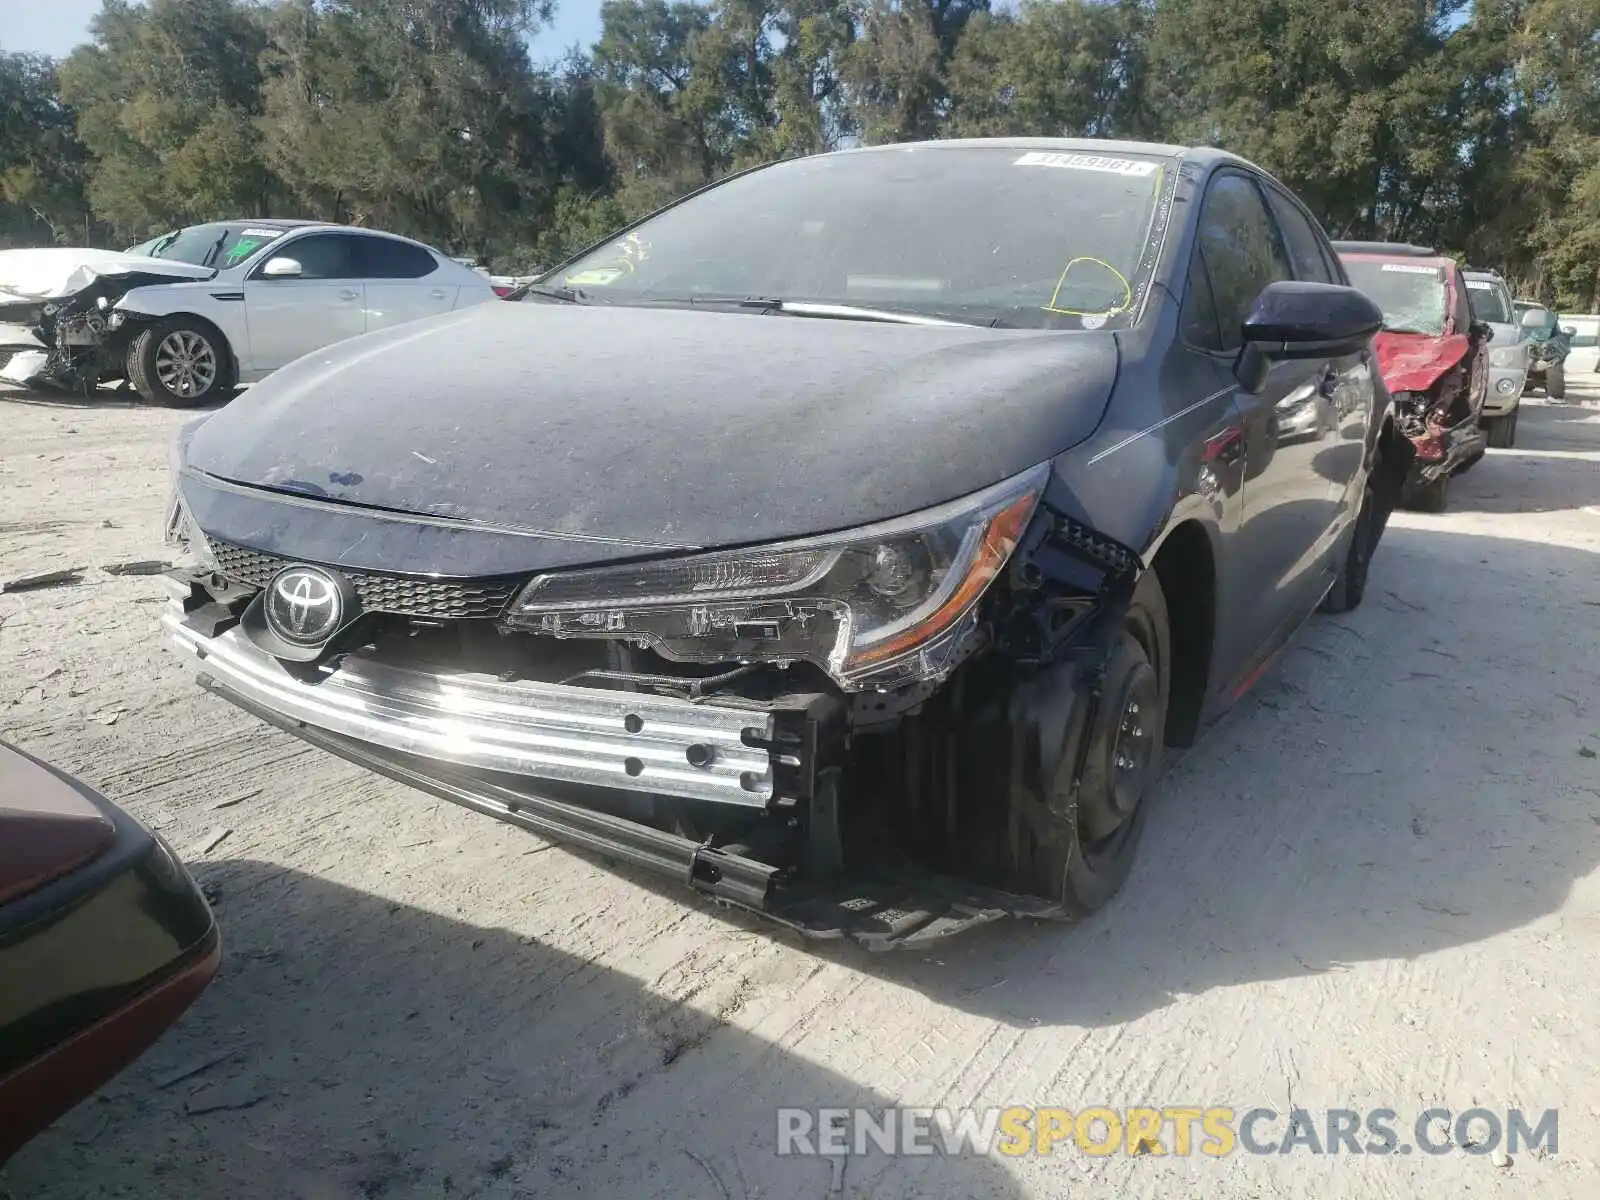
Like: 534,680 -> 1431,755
245,232 -> 366,374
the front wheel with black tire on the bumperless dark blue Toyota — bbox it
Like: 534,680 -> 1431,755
1008,571 -> 1171,918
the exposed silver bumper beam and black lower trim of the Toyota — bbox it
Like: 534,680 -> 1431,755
162,570 -> 1064,949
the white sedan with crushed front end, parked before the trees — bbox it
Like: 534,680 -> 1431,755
0,221 -> 498,406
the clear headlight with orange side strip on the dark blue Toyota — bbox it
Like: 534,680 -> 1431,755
506,462 -> 1050,690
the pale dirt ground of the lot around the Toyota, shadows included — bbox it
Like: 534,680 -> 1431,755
0,382 -> 1600,1200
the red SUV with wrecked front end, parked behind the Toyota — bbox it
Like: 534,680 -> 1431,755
1333,242 -> 1494,512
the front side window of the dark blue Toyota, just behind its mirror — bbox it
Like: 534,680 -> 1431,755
1200,171 -> 1293,350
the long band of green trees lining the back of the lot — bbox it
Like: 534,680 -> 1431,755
0,0 -> 1600,310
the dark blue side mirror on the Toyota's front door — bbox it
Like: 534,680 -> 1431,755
1234,280 -> 1384,392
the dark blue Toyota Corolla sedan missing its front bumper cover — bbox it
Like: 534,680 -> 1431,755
165,139 -> 1410,944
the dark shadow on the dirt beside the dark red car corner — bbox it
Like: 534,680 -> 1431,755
0,859 -> 1022,1200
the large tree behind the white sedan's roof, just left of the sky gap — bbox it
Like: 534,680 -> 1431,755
258,0 -> 558,254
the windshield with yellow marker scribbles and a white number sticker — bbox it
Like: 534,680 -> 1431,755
544,147 -> 1168,330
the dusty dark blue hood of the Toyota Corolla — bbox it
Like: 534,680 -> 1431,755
186,302 -> 1117,570
